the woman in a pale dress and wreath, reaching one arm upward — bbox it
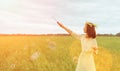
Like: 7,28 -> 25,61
57,22 -> 98,71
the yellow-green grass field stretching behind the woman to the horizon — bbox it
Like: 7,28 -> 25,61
0,36 -> 120,71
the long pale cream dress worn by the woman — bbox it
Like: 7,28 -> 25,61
73,33 -> 97,71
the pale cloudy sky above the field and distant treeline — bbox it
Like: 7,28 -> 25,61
0,0 -> 120,34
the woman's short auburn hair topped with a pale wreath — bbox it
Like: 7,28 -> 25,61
86,22 -> 96,38
